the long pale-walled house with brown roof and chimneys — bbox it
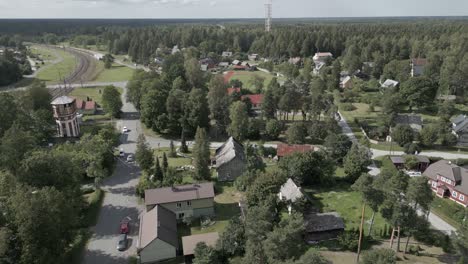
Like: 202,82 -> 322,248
145,182 -> 215,220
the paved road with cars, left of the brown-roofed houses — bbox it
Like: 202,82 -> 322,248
83,87 -> 143,264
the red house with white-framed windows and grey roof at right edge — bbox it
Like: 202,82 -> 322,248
423,160 -> 468,207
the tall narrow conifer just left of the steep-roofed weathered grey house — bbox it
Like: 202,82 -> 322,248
193,127 -> 211,181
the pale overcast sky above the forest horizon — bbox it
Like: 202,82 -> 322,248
0,0 -> 468,18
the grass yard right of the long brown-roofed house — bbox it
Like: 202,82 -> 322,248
190,183 -> 242,235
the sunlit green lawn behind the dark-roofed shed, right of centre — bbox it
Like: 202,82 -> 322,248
304,184 -> 385,237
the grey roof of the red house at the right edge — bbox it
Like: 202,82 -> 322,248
423,160 -> 468,195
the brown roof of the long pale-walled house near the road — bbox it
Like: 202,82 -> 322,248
145,182 -> 215,205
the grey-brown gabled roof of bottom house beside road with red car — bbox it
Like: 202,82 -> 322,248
138,205 -> 179,250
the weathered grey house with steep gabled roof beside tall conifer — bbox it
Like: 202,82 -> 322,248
215,137 -> 246,181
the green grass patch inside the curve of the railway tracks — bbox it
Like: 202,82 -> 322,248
37,49 -> 78,84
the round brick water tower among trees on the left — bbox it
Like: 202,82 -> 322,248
51,96 -> 80,137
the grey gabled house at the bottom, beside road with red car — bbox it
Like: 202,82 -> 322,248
136,205 -> 179,263
